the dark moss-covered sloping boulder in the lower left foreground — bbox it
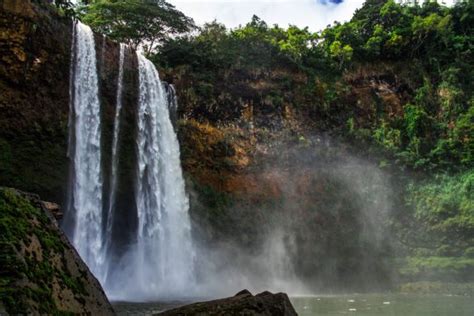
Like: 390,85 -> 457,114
0,187 -> 114,315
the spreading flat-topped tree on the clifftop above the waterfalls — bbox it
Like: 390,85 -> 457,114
78,0 -> 194,54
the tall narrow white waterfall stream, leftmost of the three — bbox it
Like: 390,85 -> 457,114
66,22 -> 104,275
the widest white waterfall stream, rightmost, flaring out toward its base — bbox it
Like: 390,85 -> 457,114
130,54 -> 194,295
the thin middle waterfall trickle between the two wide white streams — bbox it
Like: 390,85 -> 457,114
103,44 -> 126,280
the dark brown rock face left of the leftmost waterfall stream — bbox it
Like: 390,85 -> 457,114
0,0 -> 72,202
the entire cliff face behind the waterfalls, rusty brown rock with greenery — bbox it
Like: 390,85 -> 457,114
0,0 -> 474,296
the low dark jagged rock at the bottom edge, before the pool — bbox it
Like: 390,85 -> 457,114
158,290 -> 298,316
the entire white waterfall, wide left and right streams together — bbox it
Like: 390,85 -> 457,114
64,22 -> 195,301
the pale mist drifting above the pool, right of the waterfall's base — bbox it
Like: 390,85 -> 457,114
190,136 -> 395,297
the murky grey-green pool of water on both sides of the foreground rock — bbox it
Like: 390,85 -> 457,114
113,294 -> 474,316
